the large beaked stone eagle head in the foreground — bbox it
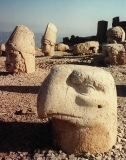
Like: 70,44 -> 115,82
37,65 -> 117,154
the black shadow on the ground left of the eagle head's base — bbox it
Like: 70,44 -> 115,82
0,122 -> 52,153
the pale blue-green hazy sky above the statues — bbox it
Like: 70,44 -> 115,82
0,0 -> 126,37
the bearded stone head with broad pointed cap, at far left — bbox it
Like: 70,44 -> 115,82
5,25 -> 35,73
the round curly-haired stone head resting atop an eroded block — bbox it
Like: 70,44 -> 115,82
106,26 -> 125,43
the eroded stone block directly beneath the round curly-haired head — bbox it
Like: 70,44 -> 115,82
102,44 -> 126,65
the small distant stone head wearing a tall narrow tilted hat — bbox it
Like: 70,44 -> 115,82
41,23 -> 57,56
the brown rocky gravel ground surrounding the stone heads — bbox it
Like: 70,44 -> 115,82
0,52 -> 126,160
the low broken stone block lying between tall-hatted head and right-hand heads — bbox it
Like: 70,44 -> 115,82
73,41 -> 99,55
